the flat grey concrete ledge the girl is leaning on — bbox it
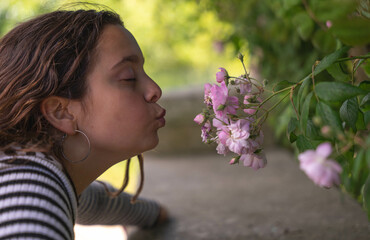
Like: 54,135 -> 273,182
128,149 -> 370,240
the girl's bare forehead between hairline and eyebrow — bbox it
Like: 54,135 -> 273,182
95,24 -> 143,67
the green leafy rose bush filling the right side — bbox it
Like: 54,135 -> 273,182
198,0 -> 370,219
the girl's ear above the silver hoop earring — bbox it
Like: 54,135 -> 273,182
40,96 -> 77,135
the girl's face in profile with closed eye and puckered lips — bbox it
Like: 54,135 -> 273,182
77,25 -> 165,158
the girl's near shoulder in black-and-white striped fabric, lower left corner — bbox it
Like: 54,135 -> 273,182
0,152 -> 76,239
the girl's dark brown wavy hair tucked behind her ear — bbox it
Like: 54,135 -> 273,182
0,10 -> 123,155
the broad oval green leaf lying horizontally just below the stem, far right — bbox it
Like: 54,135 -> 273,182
315,82 -> 366,102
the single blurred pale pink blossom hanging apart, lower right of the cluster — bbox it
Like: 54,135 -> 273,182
298,142 -> 342,188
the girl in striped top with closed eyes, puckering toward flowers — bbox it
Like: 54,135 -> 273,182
0,6 -> 166,240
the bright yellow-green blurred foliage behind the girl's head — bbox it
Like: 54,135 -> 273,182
0,0 -> 248,90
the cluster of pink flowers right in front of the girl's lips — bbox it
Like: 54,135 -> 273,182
194,68 -> 266,170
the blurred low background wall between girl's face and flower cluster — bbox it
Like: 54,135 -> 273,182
150,85 -> 274,155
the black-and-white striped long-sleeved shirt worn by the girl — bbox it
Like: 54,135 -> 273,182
0,152 -> 160,240
